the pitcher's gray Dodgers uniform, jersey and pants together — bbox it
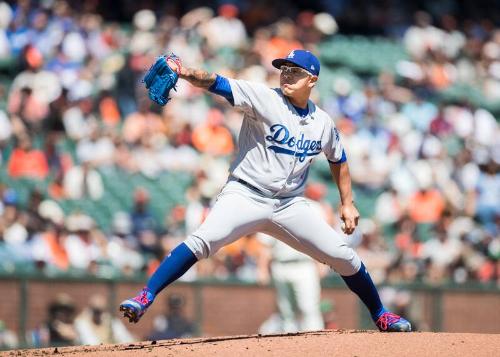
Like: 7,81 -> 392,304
185,79 -> 361,276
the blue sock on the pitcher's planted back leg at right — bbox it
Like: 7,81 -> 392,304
342,263 -> 386,321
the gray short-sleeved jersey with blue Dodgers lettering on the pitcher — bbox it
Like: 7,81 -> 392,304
229,79 -> 343,197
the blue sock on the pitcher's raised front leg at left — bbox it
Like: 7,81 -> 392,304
146,243 -> 198,296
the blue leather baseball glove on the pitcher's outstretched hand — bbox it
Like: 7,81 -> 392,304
142,53 -> 181,106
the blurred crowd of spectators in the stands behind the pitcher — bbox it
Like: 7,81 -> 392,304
0,0 -> 500,294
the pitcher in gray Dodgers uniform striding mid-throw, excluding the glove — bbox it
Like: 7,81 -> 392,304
120,50 -> 411,331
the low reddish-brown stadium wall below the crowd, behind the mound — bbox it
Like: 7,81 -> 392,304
0,278 -> 500,339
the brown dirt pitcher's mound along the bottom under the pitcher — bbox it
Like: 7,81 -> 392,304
4,330 -> 500,357
